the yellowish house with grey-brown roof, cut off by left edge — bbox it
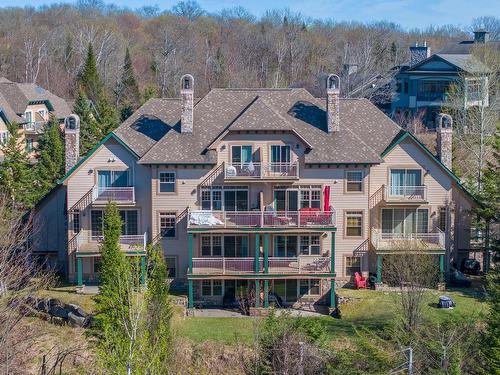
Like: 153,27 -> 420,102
0,77 -> 71,161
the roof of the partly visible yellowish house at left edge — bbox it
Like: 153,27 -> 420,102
0,77 -> 71,122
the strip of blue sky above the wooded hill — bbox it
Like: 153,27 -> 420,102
0,0 -> 500,29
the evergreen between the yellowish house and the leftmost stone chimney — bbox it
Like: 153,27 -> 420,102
34,117 -> 64,200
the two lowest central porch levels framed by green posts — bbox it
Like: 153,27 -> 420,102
187,227 -> 335,308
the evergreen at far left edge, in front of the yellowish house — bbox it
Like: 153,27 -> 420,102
0,123 -> 36,208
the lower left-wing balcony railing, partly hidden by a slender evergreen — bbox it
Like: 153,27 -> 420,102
75,231 -> 147,254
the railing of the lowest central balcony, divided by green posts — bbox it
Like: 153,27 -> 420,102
189,255 -> 330,275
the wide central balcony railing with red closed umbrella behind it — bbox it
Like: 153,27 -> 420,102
188,210 -> 335,229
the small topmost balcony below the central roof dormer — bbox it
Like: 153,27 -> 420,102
224,162 -> 299,181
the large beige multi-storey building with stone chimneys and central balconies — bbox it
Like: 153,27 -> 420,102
34,75 -> 475,307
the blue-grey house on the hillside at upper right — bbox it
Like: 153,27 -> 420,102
391,30 -> 500,129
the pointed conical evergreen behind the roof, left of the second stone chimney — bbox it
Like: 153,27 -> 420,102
117,48 -> 141,121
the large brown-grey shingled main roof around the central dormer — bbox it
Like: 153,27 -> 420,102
111,89 -> 401,164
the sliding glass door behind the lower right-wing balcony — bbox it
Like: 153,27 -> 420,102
382,208 -> 429,234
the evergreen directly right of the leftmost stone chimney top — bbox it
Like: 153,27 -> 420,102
73,88 -> 103,155
